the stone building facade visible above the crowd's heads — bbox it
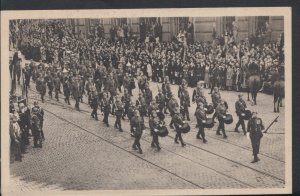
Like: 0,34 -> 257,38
66,16 -> 284,42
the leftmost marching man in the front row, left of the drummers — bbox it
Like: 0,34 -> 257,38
130,110 -> 145,154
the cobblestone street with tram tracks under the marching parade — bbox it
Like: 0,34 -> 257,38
10,52 -> 291,191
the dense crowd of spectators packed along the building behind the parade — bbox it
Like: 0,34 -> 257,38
10,20 -> 284,94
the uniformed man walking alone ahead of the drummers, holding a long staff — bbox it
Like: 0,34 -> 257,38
247,112 -> 265,163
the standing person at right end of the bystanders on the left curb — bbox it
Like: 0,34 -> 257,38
31,107 -> 42,148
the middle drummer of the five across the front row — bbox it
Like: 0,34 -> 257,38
195,102 -> 207,143
